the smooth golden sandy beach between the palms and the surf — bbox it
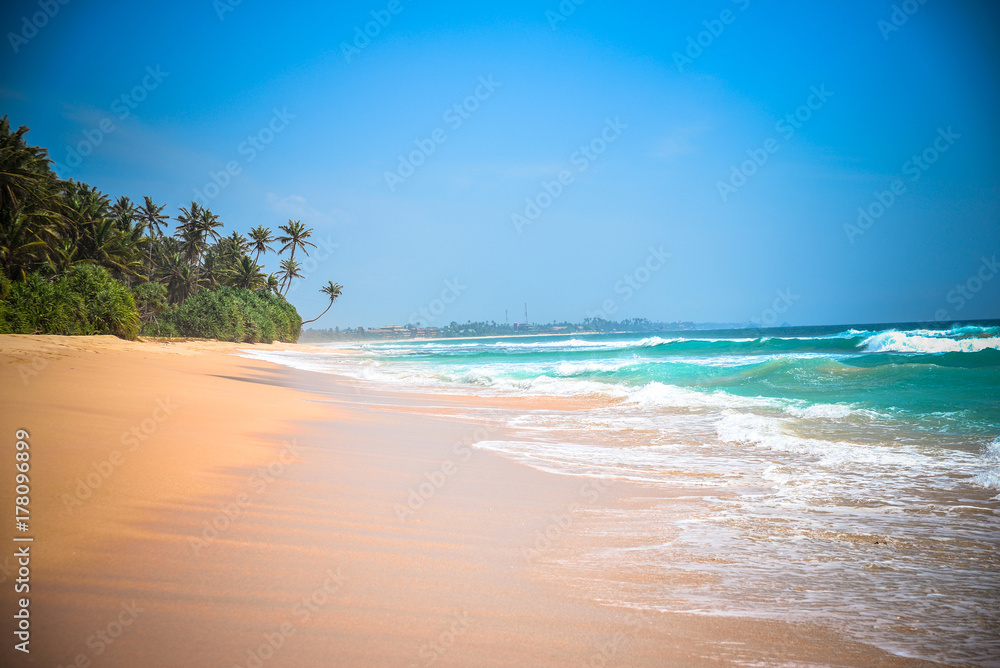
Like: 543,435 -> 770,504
0,336 -> 930,667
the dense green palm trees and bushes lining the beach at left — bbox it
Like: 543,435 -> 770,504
0,116 -> 343,343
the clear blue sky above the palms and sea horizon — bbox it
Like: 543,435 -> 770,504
0,0 -> 1000,328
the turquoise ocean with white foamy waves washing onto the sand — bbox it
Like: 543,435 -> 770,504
247,321 -> 1000,665
